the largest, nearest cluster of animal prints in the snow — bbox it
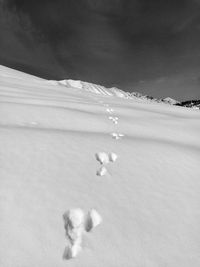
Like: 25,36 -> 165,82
63,208 -> 102,260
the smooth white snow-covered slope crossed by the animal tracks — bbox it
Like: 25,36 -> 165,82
0,66 -> 200,267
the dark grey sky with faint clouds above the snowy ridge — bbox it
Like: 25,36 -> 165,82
0,0 -> 200,100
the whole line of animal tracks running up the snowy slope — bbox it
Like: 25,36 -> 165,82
63,101 -> 124,260
